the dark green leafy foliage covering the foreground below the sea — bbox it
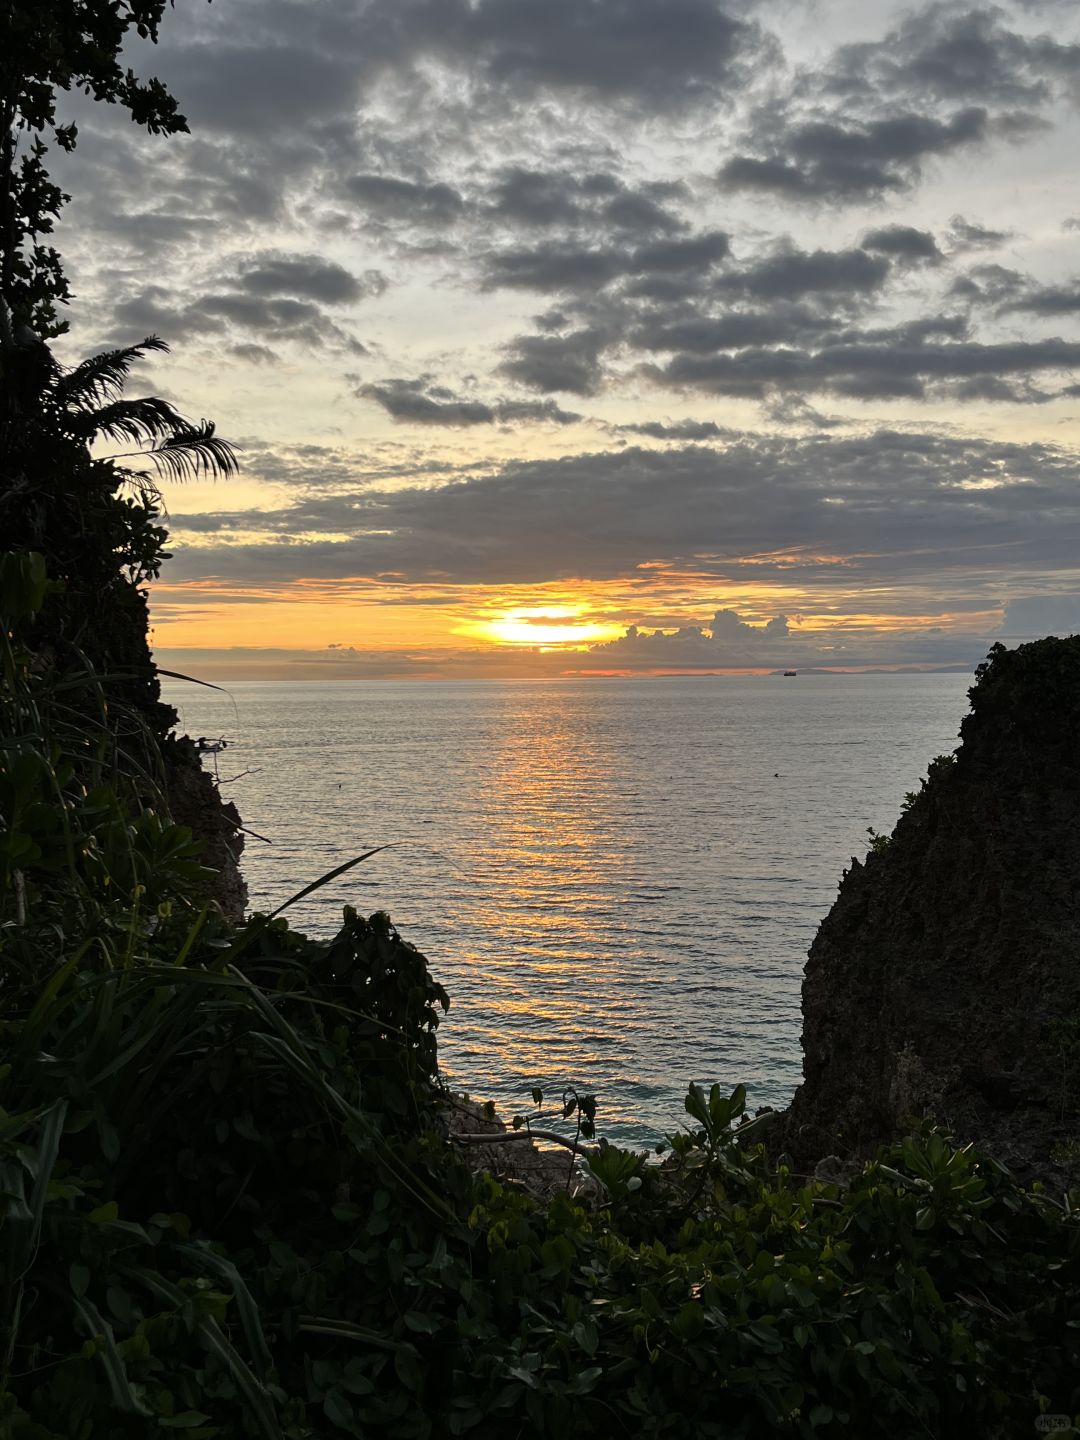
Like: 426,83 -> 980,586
0,557 -> 1080,1440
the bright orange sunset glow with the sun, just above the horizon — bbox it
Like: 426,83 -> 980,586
151,569 -> 998,678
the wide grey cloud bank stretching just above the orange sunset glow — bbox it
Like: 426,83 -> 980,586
170,431 -> 1080,595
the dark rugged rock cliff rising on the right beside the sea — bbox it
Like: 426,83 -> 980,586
783,636 -> 1080,1174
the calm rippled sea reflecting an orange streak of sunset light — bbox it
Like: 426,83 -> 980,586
167,675 -> 971,1143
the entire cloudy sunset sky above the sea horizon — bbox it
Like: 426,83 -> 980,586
55,0 -> 1080,680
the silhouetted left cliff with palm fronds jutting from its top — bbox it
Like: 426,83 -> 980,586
0,336 -> 245,920
